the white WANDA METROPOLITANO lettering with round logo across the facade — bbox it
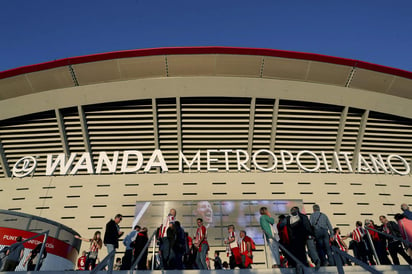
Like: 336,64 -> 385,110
12,149 -> 411,177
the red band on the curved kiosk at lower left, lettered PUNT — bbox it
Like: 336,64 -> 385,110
0,227 -> 79,263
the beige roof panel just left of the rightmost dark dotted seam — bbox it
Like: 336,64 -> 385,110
307,62 -> 352,86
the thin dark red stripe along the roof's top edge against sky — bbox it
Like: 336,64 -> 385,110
0,47 -> 412,79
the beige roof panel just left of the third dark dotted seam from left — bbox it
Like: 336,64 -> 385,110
216,55 -> 262,77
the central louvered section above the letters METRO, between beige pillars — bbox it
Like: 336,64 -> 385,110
181,97 -> 250,172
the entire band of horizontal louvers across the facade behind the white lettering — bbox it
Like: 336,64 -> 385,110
0,97 -> 412,176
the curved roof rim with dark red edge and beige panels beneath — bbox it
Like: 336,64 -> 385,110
0,47 -> 412,99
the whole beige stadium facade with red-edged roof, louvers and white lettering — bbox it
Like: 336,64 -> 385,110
0,47 -> 412,268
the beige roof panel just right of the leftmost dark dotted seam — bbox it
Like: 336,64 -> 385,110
73,59 -> 120,85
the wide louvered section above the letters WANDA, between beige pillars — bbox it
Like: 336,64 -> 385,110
84,100 -> 155,173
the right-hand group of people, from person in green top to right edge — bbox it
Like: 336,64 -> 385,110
260,204 -> 412,268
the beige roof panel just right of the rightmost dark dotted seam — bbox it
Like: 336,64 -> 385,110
350,69 -> 395,92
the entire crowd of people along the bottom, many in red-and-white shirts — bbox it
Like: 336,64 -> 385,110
0,204 -> 412,271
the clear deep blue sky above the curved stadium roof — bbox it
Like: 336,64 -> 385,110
0,0 -> 412,71
